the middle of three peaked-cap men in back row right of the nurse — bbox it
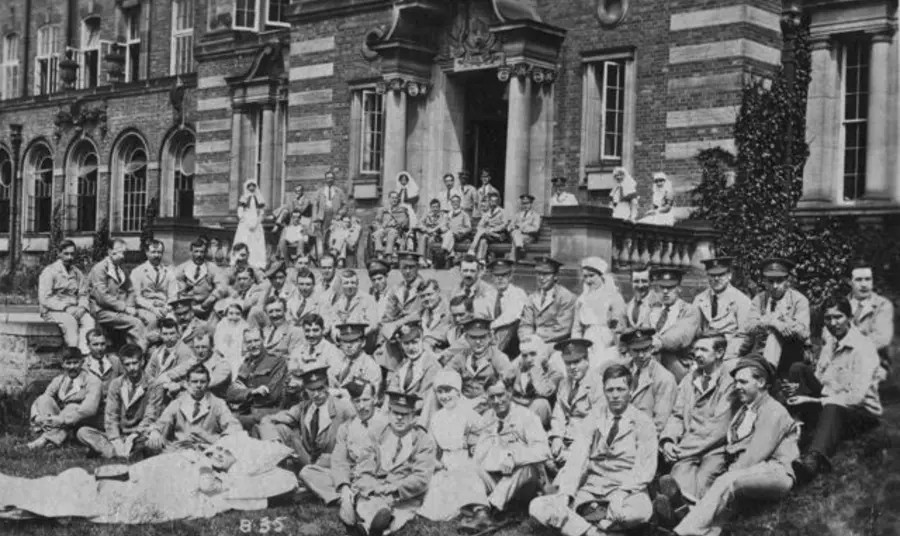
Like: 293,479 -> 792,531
694,257 -> 751,359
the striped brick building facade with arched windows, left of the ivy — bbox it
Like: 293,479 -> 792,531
0,0 -> 781,264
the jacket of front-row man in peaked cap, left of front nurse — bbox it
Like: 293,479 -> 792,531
355,426 -> 437,502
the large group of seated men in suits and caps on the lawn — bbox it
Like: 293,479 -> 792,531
29,234 -> 893,536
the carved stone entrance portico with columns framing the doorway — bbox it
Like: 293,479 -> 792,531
367,0 -> 565,206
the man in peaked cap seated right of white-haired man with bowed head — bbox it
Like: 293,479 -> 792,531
550,339 -> 603,468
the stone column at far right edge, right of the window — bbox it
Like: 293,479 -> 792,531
864,32 -> 892,200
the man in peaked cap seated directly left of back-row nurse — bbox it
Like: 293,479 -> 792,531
519,257 -> 576,344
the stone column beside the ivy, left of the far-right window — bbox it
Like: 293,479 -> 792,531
801,37 -> 841,203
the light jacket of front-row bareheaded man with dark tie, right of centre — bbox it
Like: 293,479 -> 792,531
556,406 -> 657,498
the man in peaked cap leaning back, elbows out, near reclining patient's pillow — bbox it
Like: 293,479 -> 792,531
257,363 -> 354,475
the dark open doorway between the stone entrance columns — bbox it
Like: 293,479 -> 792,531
460,69 -> 508,200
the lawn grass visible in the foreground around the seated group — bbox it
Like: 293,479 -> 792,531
0,388 -> 900,536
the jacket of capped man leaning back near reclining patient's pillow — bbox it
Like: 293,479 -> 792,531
272,396 -> 356,467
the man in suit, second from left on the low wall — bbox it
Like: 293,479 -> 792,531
88,238 -> 147,349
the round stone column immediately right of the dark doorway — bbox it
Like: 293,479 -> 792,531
503,69 -> 531,208
